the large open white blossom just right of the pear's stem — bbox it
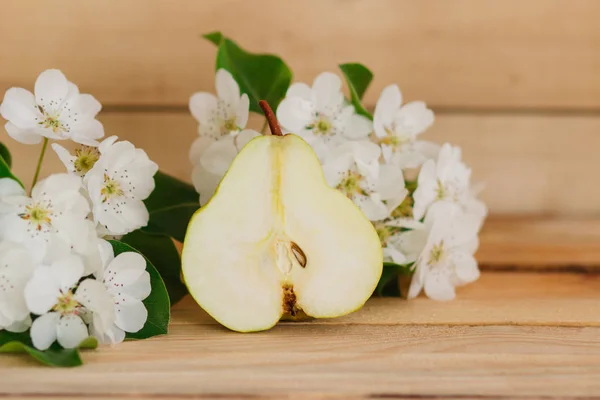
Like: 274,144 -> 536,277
277,72 -> 373,161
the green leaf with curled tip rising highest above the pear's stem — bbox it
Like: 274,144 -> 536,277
204,32 -> 292,114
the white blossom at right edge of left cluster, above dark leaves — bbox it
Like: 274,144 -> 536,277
84,137 -> 158,235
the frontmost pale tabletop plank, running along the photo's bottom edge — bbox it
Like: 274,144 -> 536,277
1,326 -> 600,398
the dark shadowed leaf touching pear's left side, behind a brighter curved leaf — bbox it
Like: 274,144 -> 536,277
121,230 -> 187,305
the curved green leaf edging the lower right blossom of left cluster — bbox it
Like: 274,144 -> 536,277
110,240 -> 171,339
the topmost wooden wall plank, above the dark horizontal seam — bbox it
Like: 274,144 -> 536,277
0,0 -> 600,109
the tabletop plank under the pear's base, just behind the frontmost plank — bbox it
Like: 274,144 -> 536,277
173,271 -> 600,327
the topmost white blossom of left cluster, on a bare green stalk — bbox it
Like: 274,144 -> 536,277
0,69 -> 104,146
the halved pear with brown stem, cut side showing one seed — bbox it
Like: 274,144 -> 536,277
182,102 -> 382,332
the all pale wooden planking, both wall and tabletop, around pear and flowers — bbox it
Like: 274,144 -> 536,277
0,0 -> 600,400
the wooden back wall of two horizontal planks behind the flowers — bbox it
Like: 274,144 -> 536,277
0,0 -> 600,216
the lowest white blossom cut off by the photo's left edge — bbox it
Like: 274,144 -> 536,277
0,241 -> 34,332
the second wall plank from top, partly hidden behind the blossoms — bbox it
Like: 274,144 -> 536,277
8,112 -> 600,217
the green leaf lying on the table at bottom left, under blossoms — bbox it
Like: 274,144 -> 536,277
0,331 -> 98,367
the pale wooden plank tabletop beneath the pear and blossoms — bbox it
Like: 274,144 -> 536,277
0,219 -> 600,399
